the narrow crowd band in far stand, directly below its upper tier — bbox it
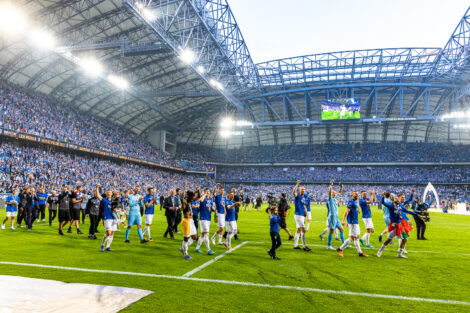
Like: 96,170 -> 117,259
217,166 -> 470,183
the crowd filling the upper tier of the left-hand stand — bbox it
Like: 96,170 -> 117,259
0,82 -> 205,169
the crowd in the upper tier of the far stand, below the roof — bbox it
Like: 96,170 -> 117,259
178,142 -> 470,163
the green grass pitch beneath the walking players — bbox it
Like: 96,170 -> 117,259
0,206 -> 470,312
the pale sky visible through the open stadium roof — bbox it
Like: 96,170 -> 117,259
227,0 -> 470,63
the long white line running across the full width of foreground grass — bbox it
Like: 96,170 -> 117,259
0,262 -> 470,306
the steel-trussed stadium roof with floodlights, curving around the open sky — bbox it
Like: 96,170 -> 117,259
0,0 -> 470,146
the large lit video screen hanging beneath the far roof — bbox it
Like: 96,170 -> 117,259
321,98 -> 361,121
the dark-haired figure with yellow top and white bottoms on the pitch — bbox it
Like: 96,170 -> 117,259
180,185 -> 197,260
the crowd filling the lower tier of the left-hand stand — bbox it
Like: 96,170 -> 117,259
0,143 -> 209,194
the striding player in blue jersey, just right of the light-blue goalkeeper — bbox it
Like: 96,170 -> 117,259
337,191 -> 368,257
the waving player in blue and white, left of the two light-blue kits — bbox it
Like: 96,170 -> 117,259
96,185 -> 118,252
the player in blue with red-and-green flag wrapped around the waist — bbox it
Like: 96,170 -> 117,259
377,194 -> 419,259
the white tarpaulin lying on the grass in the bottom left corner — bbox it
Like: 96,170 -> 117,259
0,275 -> 152,313
